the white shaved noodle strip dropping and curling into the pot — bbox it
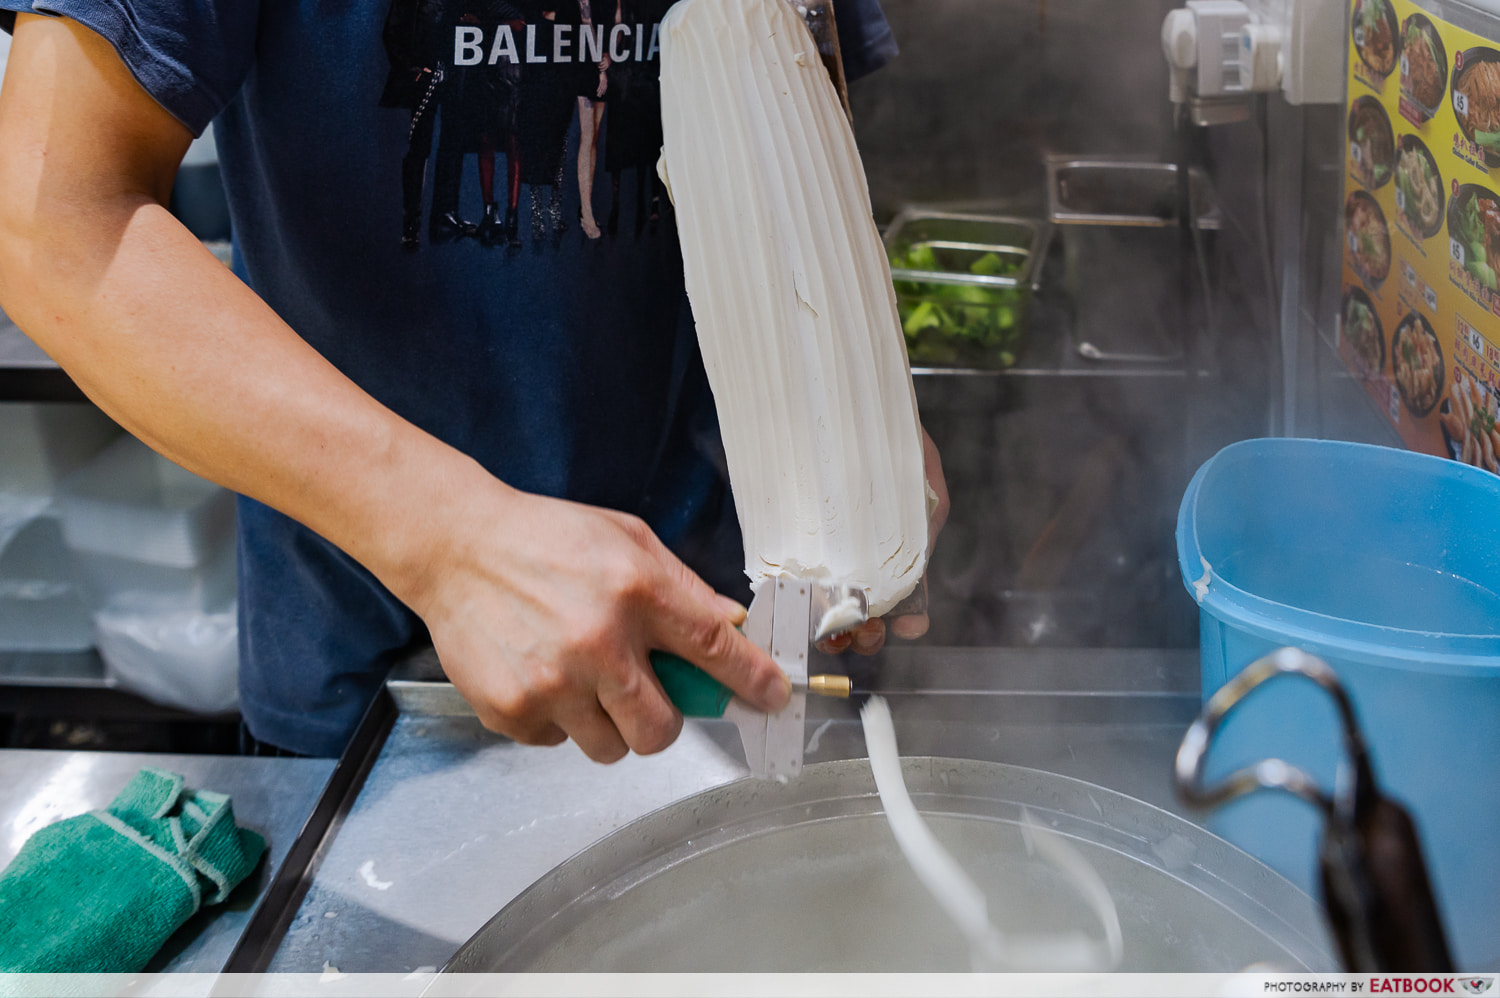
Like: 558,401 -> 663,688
860,696 -> 1125,971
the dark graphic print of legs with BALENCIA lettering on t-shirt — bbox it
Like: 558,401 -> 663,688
380,0 -> 672,252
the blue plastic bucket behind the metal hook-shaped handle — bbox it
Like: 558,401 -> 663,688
1178,440 -> 1500,968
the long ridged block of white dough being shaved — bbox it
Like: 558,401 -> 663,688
662,0 -> 927,615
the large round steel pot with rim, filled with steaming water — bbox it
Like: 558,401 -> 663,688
444,758 -> 1337,972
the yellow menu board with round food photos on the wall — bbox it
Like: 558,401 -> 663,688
1338,0 -> 1500,473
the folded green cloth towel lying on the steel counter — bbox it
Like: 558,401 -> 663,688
0,767 -> 266,974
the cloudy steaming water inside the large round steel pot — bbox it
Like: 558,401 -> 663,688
513,815 -> 1289,971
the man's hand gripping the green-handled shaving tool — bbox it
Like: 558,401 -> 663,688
410,480 -> 792,762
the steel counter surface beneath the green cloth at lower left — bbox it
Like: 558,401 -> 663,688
0,749 -> 335,972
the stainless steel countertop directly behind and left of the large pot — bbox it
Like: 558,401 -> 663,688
269,648 -> 1199,972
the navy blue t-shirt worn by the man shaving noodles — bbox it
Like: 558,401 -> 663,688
0,0 -> 896,755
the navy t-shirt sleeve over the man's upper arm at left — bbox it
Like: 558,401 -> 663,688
0,0 -> 260,135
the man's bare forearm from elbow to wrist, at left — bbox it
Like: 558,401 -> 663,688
0,195 -> 482,599
